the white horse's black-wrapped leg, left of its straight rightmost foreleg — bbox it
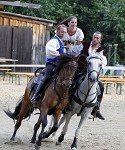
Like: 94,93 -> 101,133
56,112 -> 73,145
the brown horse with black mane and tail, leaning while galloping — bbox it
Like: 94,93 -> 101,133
4,54 -> 77,149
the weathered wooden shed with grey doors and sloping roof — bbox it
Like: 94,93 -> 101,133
0,11 -> 54,71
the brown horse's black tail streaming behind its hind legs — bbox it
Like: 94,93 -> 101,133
4,95 -> 34,120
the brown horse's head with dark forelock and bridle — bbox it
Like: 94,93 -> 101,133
58,54 -> 77,89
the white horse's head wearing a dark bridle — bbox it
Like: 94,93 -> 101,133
86,54 -> 102,82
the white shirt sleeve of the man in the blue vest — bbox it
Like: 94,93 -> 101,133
46,39 -> 60,58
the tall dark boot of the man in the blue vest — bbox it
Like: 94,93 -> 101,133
31,80 -> 45,104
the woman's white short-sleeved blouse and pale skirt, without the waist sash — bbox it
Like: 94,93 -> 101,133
63,28 -> 84,56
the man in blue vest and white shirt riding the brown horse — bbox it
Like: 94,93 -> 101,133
31,24 -> 67,104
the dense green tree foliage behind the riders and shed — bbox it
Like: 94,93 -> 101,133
6,0 -> 125,64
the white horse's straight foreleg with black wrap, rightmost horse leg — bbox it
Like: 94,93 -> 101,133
71,111 -> 89,150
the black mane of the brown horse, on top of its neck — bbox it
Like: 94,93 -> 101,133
55,54 -> 74,71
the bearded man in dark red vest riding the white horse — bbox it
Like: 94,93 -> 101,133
78,31 -> 107,120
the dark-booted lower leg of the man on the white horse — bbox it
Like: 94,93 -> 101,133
91,81 -> 105,120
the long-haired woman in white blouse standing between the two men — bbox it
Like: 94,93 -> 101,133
61,16 -> 84,56
